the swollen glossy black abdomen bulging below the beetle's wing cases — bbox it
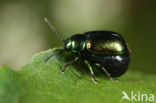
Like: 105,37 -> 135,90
82,52 -> 130,77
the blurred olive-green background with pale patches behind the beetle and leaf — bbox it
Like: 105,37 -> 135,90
0,0 -> 156,74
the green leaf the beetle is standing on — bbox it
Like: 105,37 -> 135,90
0,48 -> 156,103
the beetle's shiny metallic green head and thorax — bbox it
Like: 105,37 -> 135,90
64,34 -> 86,52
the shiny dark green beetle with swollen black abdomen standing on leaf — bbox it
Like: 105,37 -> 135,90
45,18 -> 130,83
